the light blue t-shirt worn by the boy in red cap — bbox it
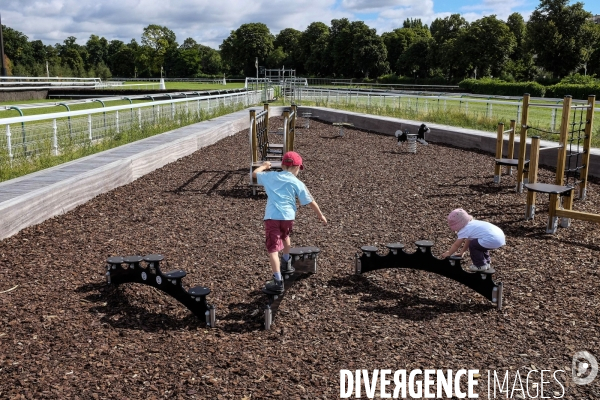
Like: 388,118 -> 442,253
256,171 -> 313,221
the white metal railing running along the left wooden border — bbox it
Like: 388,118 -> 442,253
0,91 -> 263,161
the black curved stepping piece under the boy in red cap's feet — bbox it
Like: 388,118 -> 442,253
262,247 -> 321,330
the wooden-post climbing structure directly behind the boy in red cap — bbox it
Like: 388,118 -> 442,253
250,104 -> 298,194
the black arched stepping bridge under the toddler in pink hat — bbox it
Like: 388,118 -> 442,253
355,240 -> 503,310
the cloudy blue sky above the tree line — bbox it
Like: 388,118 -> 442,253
0,0 -> 600,49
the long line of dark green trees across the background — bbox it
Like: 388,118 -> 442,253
2,0 -> 600,83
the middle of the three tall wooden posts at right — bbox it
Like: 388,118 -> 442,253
546,96 -> 573,233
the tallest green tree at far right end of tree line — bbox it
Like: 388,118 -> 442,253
527,0 -> 592,78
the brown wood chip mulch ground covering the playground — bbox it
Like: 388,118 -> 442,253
0,118 -> 600,400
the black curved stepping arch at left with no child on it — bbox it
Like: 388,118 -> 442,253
106,254 -> 216,327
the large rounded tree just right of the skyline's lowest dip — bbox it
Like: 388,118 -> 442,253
220,22 -> 274,76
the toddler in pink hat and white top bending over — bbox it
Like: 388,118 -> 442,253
442,208 -> 506,271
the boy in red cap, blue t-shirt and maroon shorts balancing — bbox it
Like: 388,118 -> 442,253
252,151 -> 327,292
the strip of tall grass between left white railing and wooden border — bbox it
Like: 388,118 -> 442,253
0,103 -> 245,182
